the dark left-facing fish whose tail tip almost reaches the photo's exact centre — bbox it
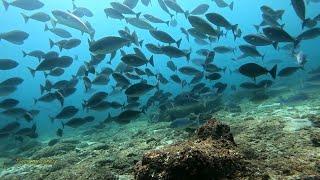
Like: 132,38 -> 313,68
125,83 -> 159,97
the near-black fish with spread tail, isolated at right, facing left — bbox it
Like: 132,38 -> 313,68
239,63 -> 277,80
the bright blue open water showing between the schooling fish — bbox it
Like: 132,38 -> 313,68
0,0 -> 320,161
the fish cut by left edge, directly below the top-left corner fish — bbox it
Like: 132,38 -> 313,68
0,30 -> 29,45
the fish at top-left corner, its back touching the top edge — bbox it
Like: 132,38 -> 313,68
2,0 -> 44,11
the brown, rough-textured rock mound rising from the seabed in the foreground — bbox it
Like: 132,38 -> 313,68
135,120 -> 249,180
